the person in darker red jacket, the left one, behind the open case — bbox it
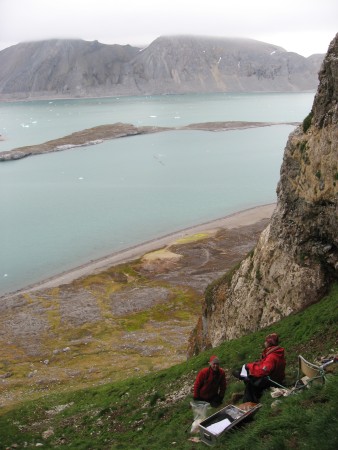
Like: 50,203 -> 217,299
194,356 -> 226,408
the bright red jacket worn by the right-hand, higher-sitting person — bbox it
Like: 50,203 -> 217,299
246,346 -> 286,383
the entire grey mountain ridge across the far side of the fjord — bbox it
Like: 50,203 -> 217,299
0,36 -> 324,100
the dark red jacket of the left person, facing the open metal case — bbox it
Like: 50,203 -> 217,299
194,367 -> 226,402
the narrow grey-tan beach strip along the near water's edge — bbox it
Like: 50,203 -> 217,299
0,203 -> 276,299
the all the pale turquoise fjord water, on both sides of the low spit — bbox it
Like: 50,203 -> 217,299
0,93 -> 314,294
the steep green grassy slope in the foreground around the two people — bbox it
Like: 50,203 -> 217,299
0,284 -> 338,450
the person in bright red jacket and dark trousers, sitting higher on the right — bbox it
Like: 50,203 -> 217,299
233,333 -> 286,403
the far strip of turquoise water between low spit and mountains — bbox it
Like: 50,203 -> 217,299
0,93 -> 314,151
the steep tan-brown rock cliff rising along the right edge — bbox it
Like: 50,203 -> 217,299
189,34 -> 338,355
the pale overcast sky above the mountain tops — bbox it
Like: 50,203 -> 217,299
0,0 -> 338,56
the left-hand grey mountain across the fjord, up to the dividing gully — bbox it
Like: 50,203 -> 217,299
0,39 -> 140,99
